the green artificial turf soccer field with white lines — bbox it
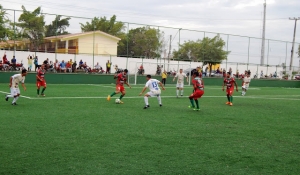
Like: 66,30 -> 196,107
0,83 -> 300,175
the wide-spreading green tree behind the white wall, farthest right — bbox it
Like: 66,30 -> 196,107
173,35 -> 229,75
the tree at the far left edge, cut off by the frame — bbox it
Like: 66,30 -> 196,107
0,5 -> 13,41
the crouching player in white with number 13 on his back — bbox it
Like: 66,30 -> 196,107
140,75 -> 165,109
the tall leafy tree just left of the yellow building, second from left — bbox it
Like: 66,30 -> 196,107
17,5 -> 45,50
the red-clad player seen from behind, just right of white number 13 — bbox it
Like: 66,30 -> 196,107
189,71 -> 204,111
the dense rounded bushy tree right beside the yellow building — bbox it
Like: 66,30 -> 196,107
124,27 -> 161,59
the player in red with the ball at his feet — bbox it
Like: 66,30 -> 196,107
107,69 -> 131,104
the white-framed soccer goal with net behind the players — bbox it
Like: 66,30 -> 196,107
128,61 -> 192,85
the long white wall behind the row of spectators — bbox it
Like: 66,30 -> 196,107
0,51 -> 283,77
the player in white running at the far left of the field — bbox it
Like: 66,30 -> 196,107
5,69 -> 27,105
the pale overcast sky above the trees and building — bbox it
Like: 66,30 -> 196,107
0,0 -> 300,66
